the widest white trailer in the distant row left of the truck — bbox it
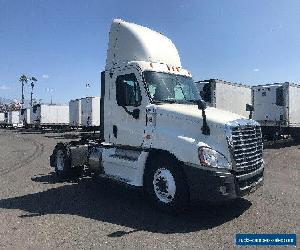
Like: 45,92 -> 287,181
30,104 -> 69,126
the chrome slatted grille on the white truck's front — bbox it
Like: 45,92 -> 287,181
231,125 -> 263,174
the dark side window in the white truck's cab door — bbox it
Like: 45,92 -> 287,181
116,73 -> 142,107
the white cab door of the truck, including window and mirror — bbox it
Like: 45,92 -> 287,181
109,67 -> 148,147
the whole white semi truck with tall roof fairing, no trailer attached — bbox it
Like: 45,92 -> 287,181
50,20 -> 264,211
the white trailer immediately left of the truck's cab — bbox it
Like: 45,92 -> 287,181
81,96 -> 100,127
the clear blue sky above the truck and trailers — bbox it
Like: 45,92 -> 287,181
0,0 -> 300,103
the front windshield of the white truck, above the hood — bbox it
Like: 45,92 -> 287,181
144,71 -> 201,103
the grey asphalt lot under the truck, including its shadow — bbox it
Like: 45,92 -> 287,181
0,129 -> 300,249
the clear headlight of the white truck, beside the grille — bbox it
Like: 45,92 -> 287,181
198,147 -> 231,169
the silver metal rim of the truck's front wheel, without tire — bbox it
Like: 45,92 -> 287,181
153,168 -> 176,203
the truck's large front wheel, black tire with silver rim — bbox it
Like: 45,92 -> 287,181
144,155 -> 189,213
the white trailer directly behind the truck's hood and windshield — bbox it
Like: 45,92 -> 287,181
195,79 -> 252,117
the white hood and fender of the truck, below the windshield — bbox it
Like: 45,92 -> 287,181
148,104 -> 245,164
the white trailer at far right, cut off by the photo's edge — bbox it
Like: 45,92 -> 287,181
252,82 -> 300,139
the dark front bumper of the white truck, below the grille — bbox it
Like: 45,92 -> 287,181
183,163 -> 264,201
